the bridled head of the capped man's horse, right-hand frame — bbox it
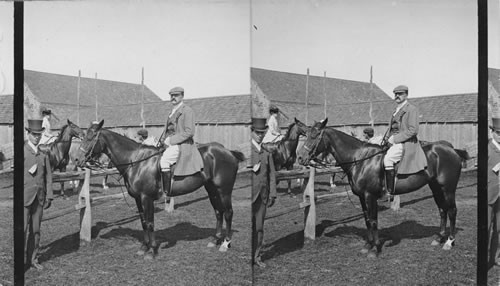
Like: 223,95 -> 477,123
297,118 -> 328,165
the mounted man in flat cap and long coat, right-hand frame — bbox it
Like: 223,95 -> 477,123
383,85 -> 427,195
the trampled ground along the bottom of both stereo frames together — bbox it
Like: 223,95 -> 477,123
0,169 -> 500,285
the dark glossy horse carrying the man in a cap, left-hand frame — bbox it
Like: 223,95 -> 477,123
76,120 -> 245,260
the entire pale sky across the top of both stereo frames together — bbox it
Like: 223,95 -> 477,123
0,0 -> 500,99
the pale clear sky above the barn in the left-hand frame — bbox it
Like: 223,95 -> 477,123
24,0 -> 250,99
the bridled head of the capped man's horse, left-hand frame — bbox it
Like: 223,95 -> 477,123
75,119 -> 104,167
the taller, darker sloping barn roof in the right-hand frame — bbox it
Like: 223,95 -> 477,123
251,68 -> 390,104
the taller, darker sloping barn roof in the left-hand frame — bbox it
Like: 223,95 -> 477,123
24,70 -> 161,106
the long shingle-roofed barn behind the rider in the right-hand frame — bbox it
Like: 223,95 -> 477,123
252,68 -> 477,148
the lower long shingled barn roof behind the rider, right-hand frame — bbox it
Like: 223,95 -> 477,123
275,93 -> 477,126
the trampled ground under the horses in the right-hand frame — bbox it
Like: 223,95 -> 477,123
253,172 -> 492,285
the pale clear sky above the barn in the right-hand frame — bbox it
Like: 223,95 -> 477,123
252,0 -> 484,97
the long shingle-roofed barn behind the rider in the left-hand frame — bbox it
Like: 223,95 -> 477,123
24,70 -> 251,160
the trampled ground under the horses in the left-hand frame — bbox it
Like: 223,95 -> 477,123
0,171 -> 252,285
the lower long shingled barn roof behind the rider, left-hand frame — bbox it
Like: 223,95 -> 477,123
47,95 -> 251,129
